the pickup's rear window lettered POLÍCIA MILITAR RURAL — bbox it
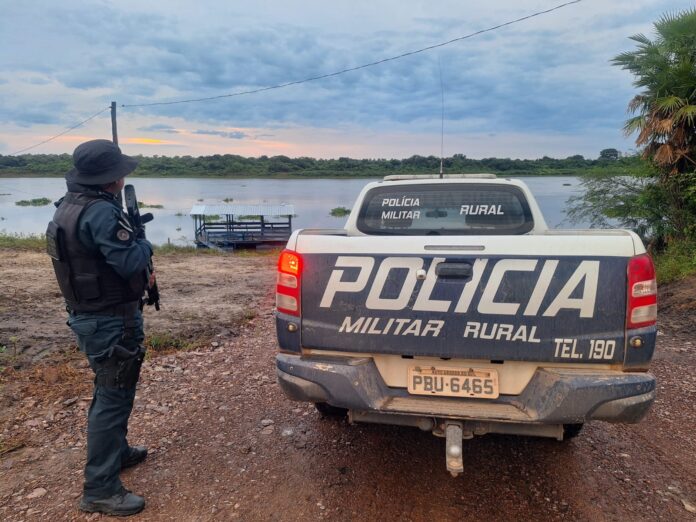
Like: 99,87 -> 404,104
357,183 -> 534,236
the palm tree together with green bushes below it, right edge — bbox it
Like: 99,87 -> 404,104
569,9 -> 696,282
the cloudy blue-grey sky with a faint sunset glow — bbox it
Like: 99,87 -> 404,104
0,0 -> 693,159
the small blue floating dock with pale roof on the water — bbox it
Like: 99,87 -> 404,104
189,204 -> 295,251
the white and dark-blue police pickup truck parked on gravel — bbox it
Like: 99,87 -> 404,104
276,174 -> 657,475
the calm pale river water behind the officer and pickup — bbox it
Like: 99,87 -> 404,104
0,176 -> 588,245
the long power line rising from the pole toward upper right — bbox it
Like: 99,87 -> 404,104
121,0 -> 582,108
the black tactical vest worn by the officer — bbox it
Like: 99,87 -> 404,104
46,192 -> 147,313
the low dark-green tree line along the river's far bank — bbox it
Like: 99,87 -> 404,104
0,149 -> 639,179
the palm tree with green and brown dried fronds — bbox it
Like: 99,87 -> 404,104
612,9 -> 696,177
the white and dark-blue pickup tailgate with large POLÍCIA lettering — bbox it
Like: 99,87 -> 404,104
295,231 -> 634,364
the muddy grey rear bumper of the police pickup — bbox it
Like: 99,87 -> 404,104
276,354 -> 655,424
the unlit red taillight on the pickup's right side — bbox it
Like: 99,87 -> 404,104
626,254 -> 657,330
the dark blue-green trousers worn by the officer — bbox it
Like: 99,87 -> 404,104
68,306 -> 144,500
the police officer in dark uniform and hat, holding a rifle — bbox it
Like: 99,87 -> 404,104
46,140 -> 154,515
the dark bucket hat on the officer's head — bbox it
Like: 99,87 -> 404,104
65,140 -> 138,185
